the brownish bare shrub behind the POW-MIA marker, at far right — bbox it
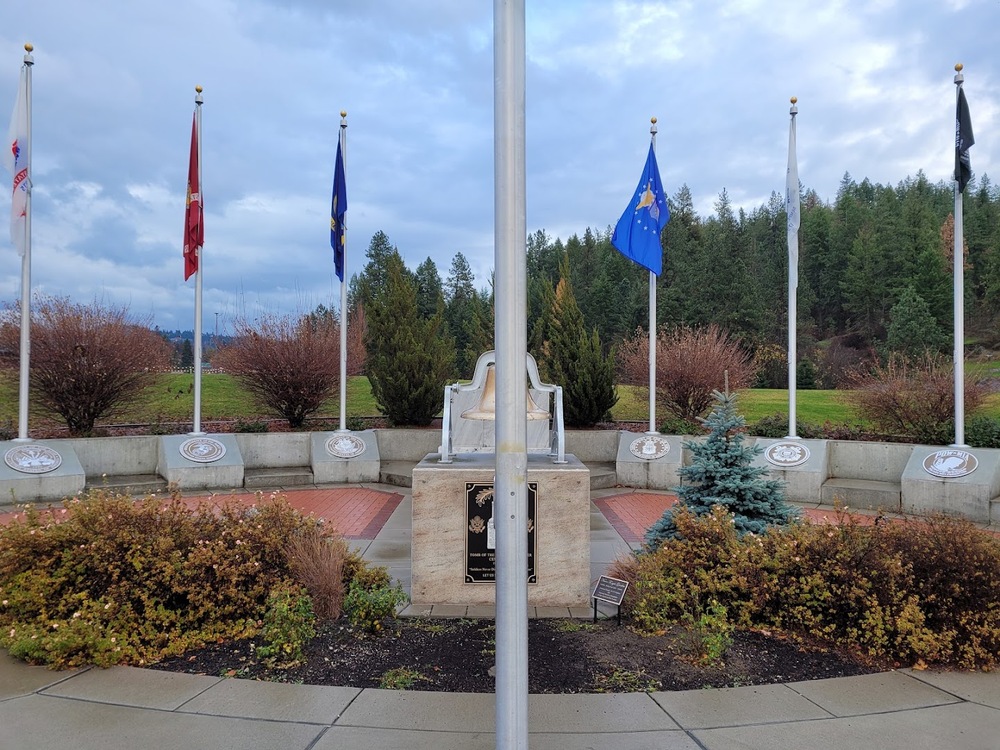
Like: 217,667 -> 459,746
845,354 -> 989,445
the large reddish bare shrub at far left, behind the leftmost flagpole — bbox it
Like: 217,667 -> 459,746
0,298 -> 170,436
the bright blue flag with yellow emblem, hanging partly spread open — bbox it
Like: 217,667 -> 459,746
611,143 -> 670,276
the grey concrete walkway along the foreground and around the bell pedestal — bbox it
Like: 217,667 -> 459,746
0,486 -> 1000,750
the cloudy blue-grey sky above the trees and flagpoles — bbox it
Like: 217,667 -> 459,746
0,0 -> 1000,332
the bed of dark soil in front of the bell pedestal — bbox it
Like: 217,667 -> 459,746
152,618 -> 888,693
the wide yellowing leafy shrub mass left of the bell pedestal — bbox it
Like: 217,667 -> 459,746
0,490 -> 356,667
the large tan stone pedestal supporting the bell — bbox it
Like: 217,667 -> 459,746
410,453 -> 590,607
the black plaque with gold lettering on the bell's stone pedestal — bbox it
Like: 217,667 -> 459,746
465,482 -> 538,584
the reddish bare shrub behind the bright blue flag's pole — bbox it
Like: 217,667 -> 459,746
618,324 -> 755,420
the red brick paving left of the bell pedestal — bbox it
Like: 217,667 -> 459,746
0,487 -> 403,539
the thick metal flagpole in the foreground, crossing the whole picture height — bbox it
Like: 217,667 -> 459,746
493,0 -> 528,750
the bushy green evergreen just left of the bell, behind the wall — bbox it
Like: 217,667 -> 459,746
365,252 -> 455,426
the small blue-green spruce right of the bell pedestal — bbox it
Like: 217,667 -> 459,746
646,391 -> 798,550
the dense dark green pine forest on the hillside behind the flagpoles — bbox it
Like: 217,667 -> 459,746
352,172 -> 1000,387
